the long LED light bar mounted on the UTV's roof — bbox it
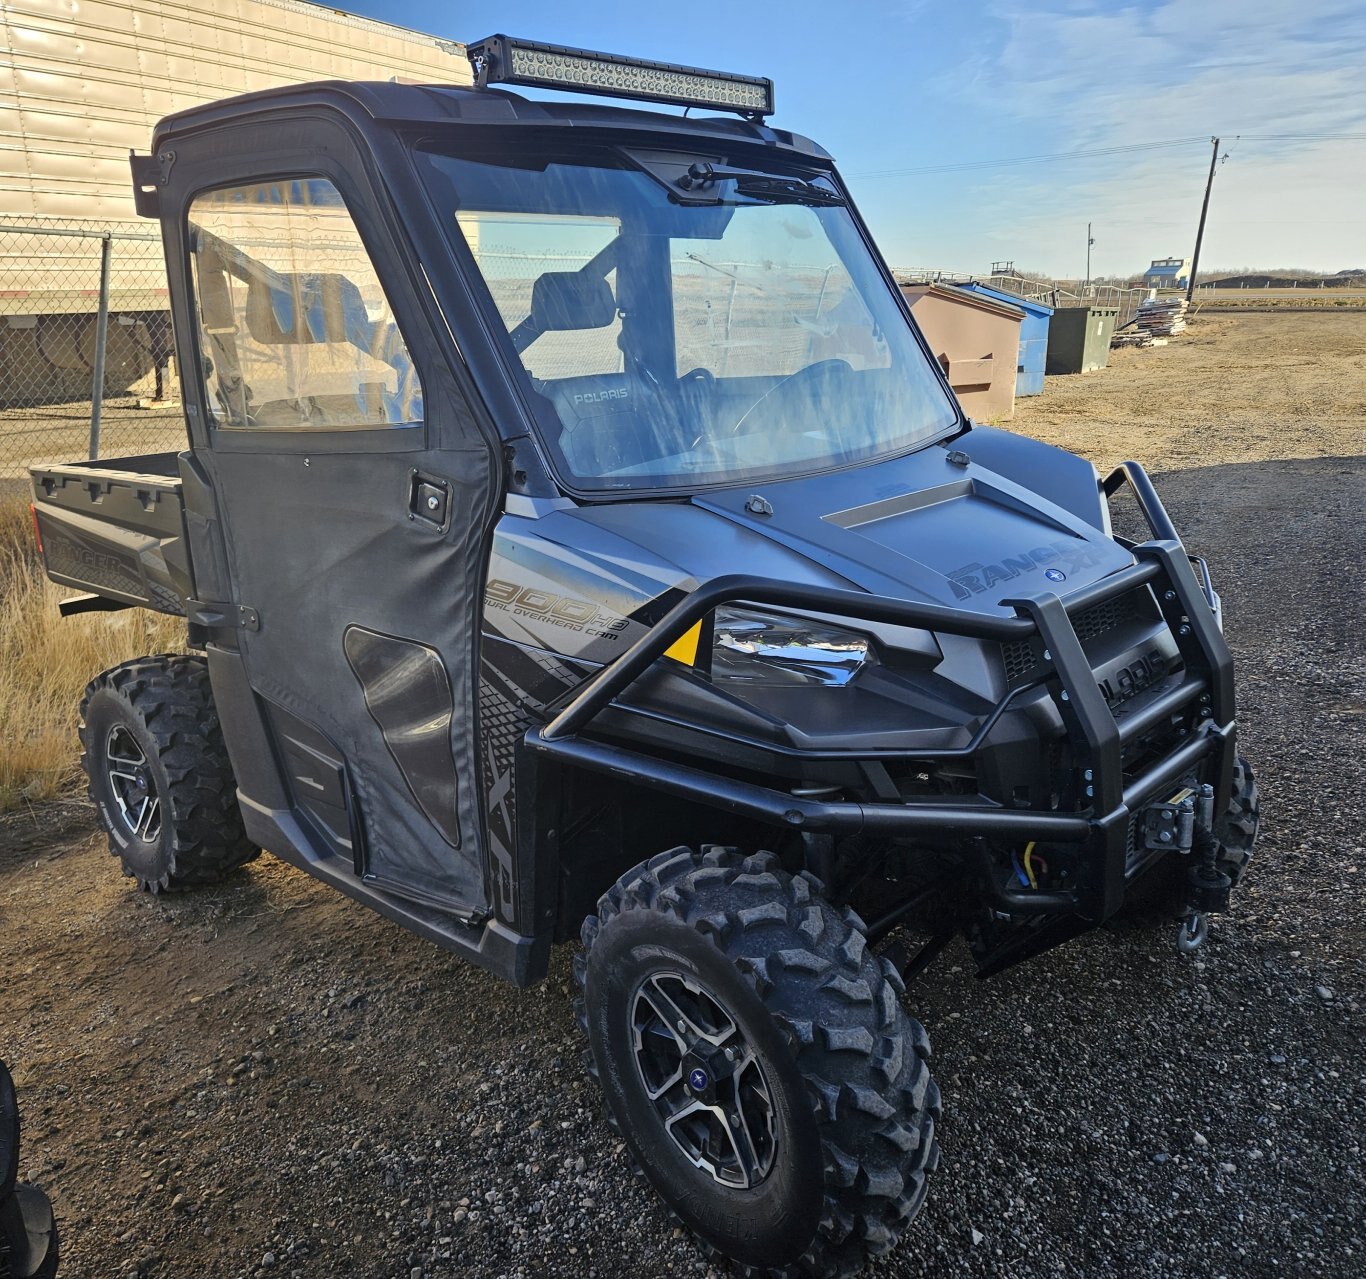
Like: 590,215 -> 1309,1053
466,36 -> 773,120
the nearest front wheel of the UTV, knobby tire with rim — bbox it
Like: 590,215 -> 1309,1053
575,847 -> 940,1276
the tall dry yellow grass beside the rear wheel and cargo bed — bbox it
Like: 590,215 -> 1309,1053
0,496 -> 184,813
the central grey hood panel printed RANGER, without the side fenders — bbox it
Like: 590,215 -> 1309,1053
694,448 -> 1134,615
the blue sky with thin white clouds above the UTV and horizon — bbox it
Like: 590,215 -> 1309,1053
336,0 -> 1366,276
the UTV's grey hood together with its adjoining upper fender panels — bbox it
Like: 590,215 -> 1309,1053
486,430 -> 1132,663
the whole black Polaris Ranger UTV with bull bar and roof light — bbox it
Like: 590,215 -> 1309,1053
26,37 -> 1257,1275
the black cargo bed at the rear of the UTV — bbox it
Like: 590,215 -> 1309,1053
29,452 -> 191,616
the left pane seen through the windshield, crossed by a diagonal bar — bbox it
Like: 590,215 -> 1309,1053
455,209 -> 626,381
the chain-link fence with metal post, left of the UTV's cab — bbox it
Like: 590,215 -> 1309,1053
0,219 -> 184,481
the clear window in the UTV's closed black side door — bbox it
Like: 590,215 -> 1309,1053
190,178 -> 422,430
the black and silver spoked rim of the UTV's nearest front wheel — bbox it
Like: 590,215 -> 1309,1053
631,972 -> 777,1190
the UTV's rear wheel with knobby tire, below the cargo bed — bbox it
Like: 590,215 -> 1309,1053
81,655 -> 261,892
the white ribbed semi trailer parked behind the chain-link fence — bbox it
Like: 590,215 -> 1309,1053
0,0 -> 470,407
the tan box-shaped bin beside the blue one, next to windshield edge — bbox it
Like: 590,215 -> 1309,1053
902,284 -> 1025,422
